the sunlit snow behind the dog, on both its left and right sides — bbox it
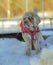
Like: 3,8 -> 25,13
0,19 -> 53,35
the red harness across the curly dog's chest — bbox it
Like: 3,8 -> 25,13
20,22 -> 40,41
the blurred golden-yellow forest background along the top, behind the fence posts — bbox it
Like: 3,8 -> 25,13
0,0 -> 53,18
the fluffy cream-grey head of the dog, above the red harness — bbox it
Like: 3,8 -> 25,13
22,12 -> 40,30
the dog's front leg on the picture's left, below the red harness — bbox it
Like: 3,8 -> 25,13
22,33 -> 31,55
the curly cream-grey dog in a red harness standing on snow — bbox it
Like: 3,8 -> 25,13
20,12 -> 40,55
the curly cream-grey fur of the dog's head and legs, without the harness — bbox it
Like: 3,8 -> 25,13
22,12 -> 40,55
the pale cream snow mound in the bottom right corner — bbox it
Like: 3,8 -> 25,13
30,45 -> 53,65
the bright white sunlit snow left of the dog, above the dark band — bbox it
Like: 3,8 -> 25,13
0,21 -> 21,34
